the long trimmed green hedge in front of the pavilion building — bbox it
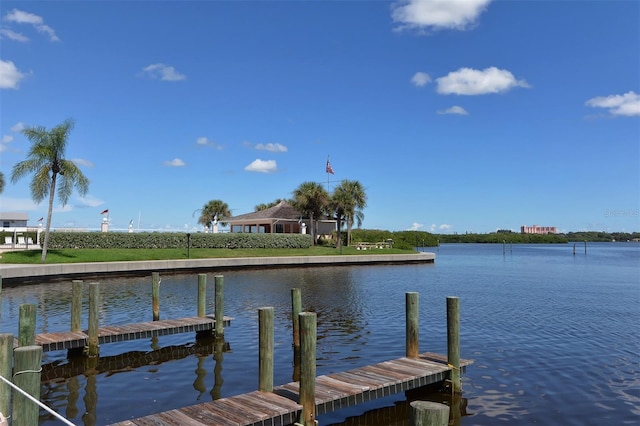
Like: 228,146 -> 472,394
48,232 -> 312,249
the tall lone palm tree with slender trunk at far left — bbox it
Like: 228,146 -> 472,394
11,119 -> 89,262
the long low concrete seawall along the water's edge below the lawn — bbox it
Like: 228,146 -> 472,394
0,252 -> 436,285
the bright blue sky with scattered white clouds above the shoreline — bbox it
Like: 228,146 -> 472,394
0,0 -> 640,233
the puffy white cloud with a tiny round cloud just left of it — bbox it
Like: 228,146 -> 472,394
436,67 -> 530,95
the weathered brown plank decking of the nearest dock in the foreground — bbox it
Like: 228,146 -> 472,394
115,352 -> 473,426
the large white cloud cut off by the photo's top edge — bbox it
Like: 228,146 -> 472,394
391,0 -> 491,30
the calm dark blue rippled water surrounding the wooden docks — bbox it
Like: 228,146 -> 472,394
0,243 -> 640,426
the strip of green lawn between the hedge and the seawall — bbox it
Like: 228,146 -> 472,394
0,247 -> 416,264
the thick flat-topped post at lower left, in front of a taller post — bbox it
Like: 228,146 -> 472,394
11,346 -> 42,426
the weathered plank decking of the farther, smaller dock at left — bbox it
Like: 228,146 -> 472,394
14,316 -> 232,352
